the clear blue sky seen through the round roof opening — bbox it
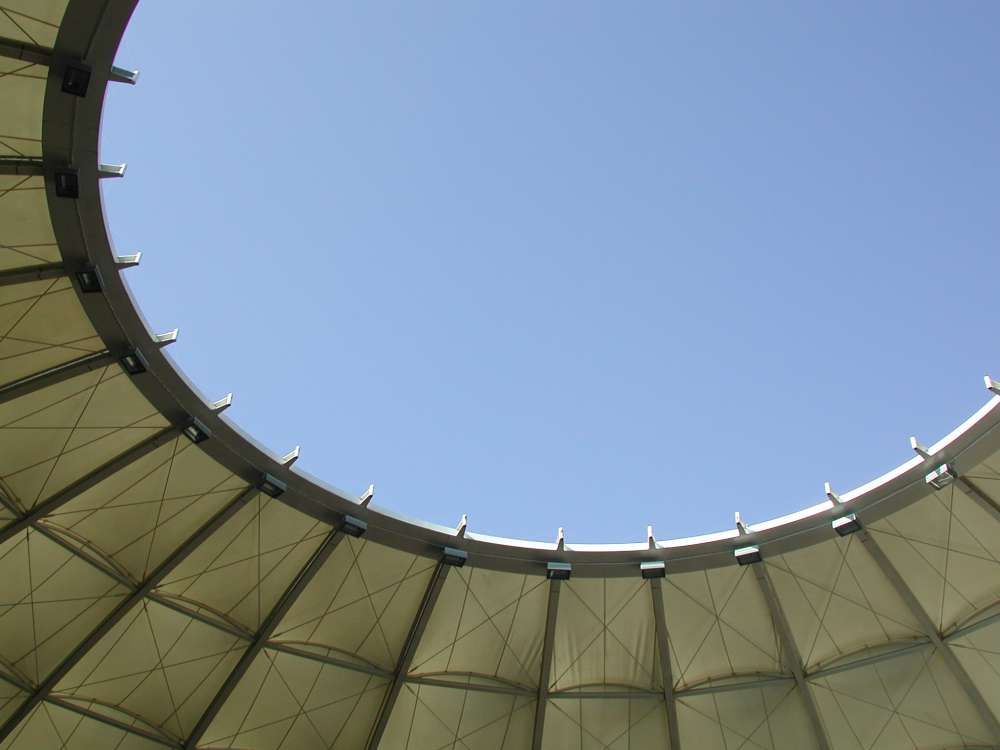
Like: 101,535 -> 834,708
102,0 -> 1000,542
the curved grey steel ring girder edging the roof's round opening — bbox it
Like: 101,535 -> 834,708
43,0 -> 1000,577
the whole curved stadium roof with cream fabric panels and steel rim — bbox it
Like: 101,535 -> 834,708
0,0 -> 1000,750
